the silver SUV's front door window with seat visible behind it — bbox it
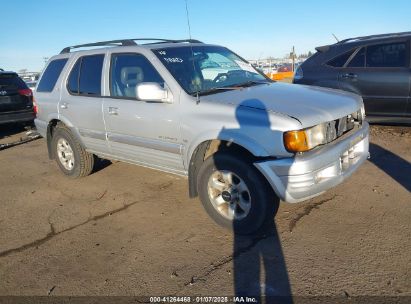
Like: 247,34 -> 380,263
110,54 -> 164,98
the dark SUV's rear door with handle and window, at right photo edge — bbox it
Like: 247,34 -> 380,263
339,41 -> 411,116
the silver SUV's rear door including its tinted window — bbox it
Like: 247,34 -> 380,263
59,54 -> 109,153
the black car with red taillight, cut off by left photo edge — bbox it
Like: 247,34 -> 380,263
0,71 -> 35,124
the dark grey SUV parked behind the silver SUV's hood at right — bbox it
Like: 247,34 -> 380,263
294,32 -> 411,123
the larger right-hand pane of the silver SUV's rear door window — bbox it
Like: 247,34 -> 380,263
79,55 -> 104,96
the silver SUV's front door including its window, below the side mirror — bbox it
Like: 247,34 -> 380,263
103,53 -> 184,173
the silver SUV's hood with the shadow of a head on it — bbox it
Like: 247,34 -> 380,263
201,82 -> 362,128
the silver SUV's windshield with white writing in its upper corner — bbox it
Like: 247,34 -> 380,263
153,46 -> 271,95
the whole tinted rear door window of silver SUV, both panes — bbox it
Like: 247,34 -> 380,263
67,54 -> 104,96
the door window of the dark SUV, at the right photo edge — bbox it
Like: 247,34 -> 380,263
367,42 -> 408,67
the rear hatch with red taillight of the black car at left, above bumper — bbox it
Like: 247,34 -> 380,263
0,73 -> 33,112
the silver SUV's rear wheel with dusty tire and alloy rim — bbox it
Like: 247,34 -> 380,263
52,125 -> 94,178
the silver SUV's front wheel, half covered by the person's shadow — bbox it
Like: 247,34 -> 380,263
197,152 -> 279,235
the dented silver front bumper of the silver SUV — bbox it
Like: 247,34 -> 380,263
254,122 -> 369,203
